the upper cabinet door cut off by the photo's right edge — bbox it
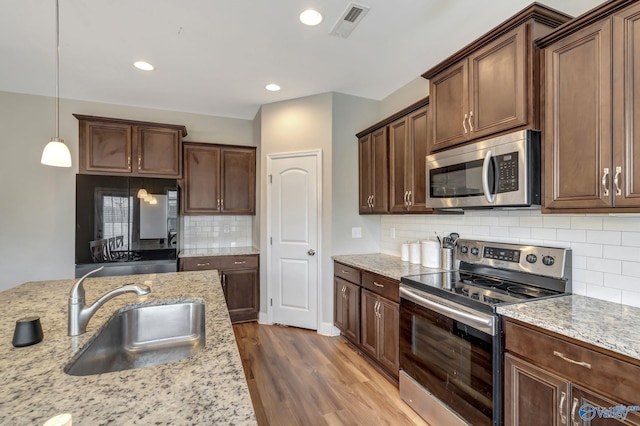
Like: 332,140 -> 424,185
611,4 -> 640,207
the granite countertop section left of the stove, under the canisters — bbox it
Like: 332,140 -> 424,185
332,253 -> 443,281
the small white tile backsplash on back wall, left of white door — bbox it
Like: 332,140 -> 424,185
180,216 -> 253,249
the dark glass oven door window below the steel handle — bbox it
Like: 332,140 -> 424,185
400,299 -> 493,425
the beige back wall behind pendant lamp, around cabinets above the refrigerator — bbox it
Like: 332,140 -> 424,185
0,92 -> 255,291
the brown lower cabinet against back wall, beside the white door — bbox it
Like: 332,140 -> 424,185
180,255 -> 260,323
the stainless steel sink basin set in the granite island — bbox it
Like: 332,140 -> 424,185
64,302 -> 205,376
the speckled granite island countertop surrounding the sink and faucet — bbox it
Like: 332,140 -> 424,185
0,271 -> 256,426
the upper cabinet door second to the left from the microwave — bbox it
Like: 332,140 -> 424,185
389,117 -> 408,213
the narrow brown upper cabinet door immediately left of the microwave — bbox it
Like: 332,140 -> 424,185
405,107 -> 433,213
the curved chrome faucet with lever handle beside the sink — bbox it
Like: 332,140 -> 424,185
69,266 -> 151,336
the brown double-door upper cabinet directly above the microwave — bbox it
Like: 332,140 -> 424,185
422,3 -> 570,152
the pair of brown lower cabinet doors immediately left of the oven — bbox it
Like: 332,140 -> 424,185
360,289 -> 400,376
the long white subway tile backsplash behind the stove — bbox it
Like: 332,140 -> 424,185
381,210 -> 640,307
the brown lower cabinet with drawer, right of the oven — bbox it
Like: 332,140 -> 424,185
504,320 -> 640,426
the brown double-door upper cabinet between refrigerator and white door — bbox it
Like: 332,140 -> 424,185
182,143 -> 256,215
